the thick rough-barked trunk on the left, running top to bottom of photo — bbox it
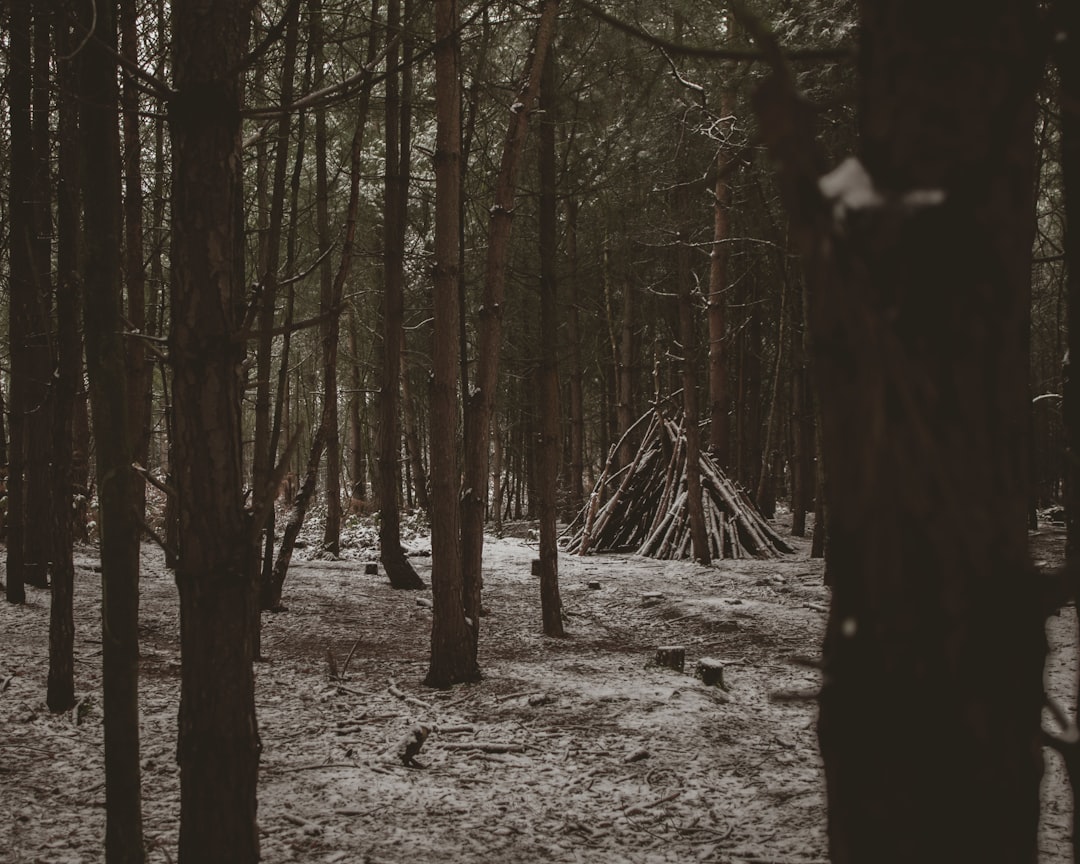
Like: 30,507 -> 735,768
170,0 -> 259,864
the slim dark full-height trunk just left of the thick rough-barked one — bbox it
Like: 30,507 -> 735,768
78,3 -> 144,864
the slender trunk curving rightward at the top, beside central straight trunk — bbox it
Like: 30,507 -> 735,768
461,0 -> 558,657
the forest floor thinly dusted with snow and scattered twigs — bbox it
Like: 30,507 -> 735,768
0,509 -> 1076,864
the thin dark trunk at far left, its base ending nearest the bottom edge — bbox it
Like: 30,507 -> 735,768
45,9 -> 82,714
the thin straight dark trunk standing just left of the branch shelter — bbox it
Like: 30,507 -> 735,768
537,42 -> 566,636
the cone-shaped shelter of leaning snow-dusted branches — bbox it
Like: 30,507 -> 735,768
566,410 -> 792,558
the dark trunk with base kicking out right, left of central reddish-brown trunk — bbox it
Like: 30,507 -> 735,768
378,0 -> 424,590
